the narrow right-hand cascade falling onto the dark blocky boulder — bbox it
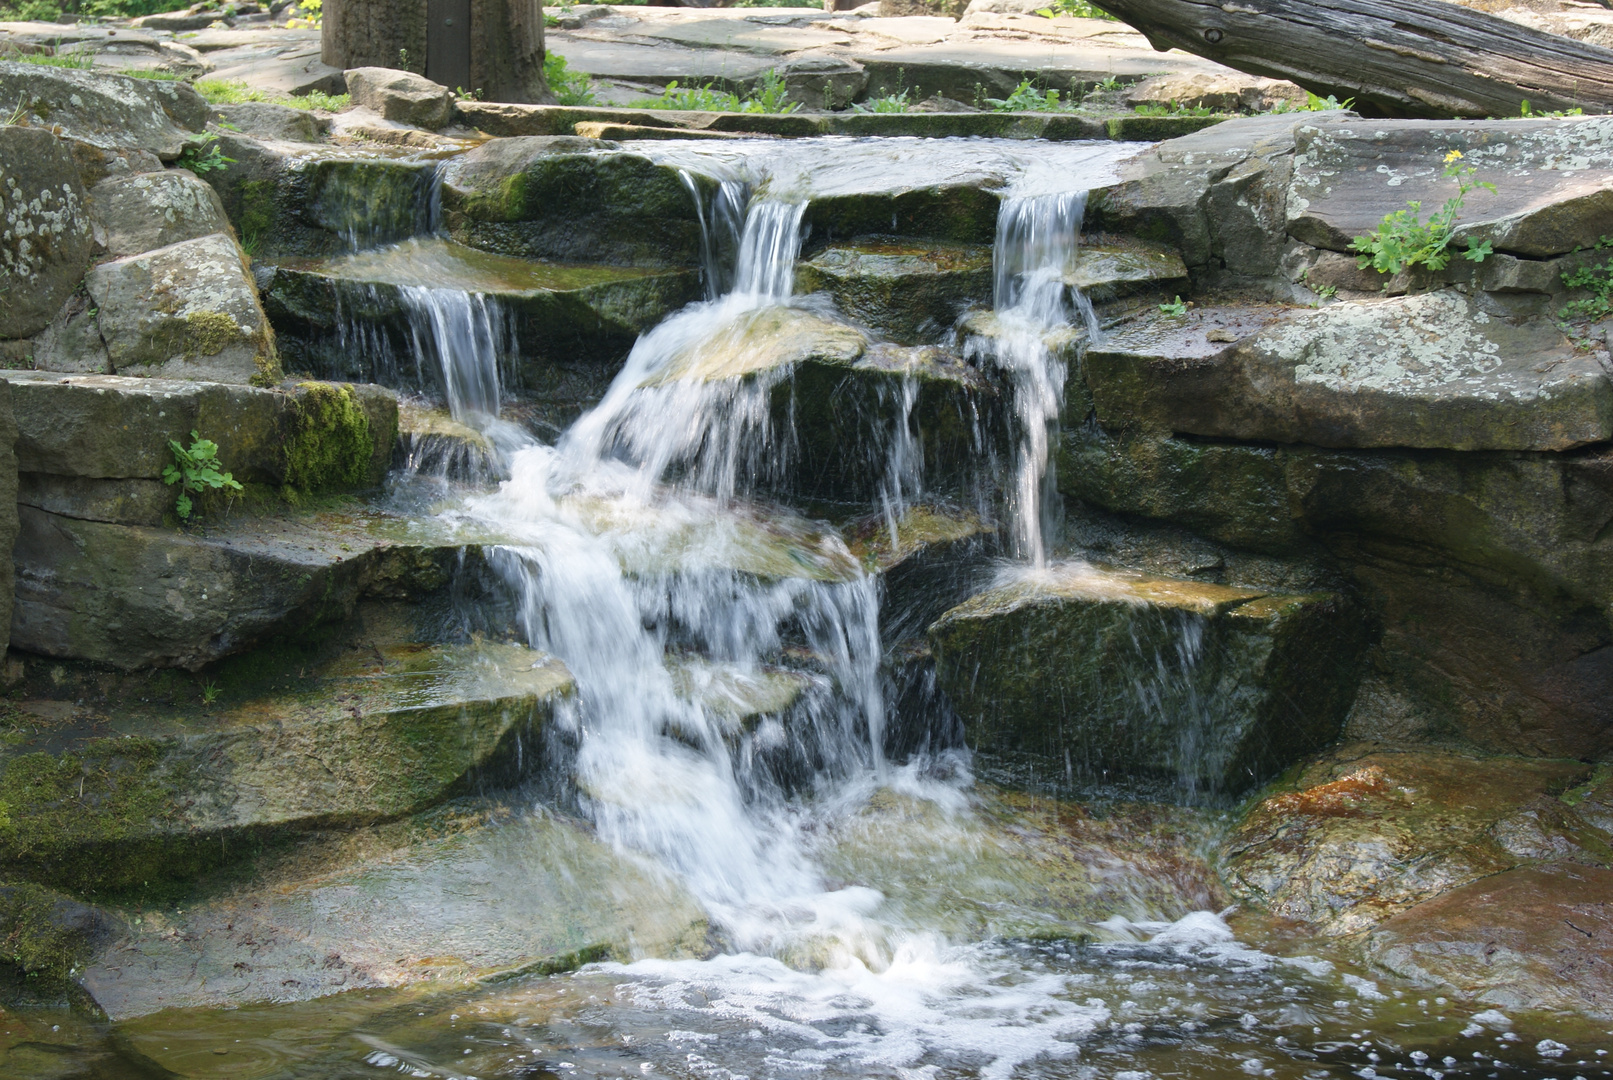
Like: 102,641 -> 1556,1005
966,190 -> 1097,566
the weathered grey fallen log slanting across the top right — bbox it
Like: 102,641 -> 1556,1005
1096,0 -> 1613,119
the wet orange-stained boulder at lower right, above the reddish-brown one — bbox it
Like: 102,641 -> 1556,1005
1223,745 -> 1613,935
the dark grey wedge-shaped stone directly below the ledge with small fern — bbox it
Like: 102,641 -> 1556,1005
11,506 -> 463,671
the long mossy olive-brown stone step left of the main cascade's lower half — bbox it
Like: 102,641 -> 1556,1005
0,643 -> 573,890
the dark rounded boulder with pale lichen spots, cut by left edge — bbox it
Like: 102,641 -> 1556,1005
0,128 -> 90,339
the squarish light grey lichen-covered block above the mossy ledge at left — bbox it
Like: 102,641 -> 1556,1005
85,234 -> 279,384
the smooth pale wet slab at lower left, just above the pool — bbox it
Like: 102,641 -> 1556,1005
82,812 -> 706,1025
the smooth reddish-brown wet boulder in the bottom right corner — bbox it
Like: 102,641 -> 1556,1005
1366,864 -> 1613,1025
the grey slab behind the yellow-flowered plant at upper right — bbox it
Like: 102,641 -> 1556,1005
1287,116 -> 1613,258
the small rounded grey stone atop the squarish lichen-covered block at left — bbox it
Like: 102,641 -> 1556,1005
90,169 -> 231,258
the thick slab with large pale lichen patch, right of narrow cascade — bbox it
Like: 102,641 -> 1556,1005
1086,290 -> 1613,450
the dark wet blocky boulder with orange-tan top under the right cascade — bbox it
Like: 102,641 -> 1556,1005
929,563 -> 1365,800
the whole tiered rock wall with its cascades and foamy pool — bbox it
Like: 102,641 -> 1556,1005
0,63 -> 1613,1077
